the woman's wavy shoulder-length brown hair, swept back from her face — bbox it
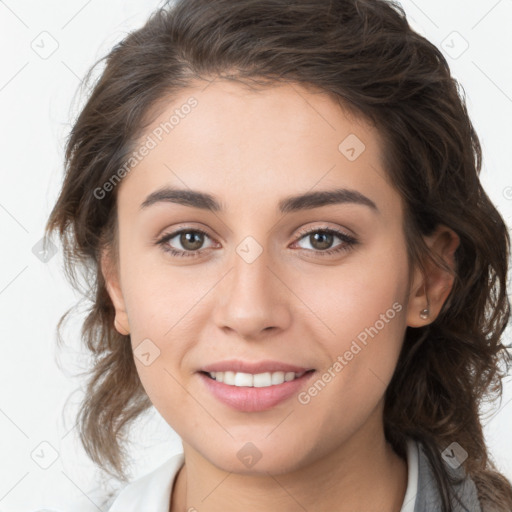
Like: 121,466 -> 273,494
46,0 -> 512,512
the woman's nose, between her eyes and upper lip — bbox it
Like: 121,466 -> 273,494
213,244 -> 293,340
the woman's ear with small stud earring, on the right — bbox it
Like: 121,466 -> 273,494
407,224 -> 460,327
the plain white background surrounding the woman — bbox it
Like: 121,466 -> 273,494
0,0 -> 512,512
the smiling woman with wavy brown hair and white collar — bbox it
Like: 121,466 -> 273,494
47,0 -> 512,512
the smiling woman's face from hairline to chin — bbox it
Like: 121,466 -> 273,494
104,80 -> 434,473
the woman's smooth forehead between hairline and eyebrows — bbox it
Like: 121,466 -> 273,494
118,80 -> 399,219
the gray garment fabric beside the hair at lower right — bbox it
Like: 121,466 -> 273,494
414,443 -> 483,512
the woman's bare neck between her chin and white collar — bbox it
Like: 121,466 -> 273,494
170,420 -> 407,512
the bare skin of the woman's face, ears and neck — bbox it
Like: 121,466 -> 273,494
102,79 -> 459,512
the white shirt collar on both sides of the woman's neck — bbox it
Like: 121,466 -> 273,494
108,439 -> 419,512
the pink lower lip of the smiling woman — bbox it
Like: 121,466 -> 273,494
199,371 -> 315,412
